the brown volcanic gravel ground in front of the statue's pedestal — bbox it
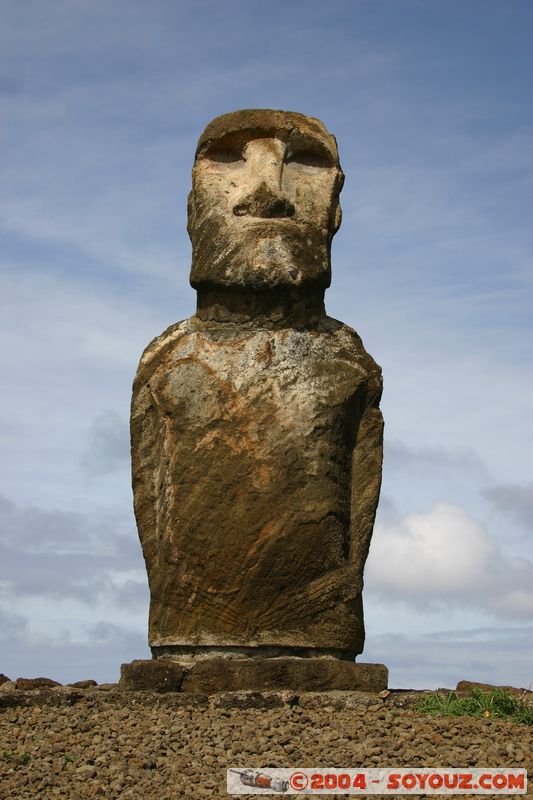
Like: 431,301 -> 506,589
0,687 -> 533,800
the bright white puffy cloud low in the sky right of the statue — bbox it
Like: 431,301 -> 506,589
366,502 -> 533,620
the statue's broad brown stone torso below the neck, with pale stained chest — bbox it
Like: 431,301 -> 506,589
132,318 -> 382,647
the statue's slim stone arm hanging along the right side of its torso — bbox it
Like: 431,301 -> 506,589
350,357 -> 383,575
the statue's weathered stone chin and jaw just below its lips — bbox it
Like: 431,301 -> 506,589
191,224 -> 330,289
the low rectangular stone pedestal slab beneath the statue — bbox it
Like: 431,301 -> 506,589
120,657 -> 389,694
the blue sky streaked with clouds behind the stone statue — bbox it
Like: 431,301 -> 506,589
0,0 -> 533,687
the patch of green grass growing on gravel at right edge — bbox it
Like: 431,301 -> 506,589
416,688 -> 533,725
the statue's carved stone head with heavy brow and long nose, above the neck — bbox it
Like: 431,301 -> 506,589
189,110 -> 343,289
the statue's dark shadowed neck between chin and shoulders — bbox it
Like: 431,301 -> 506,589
196,286 -> 326,328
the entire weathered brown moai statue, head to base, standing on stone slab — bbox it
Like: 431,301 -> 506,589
131,109 -> 383,660
